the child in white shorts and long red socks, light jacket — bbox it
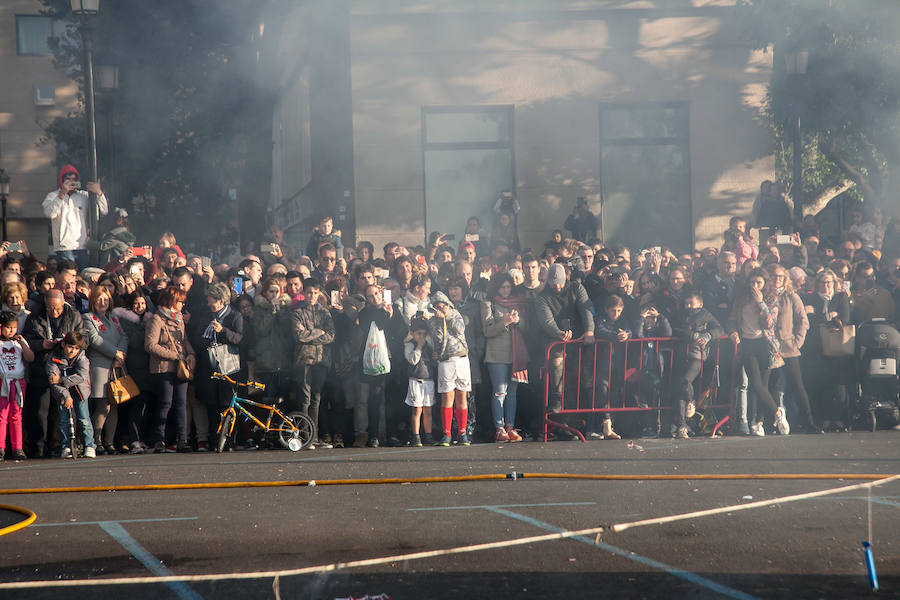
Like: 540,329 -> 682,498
428,292 -> 472,446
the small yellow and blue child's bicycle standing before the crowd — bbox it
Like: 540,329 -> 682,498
212,373 -> 316,452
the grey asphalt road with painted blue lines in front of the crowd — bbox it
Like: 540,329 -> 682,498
0,431 -> 900,600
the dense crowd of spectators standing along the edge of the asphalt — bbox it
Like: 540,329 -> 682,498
0,166 -> 900,460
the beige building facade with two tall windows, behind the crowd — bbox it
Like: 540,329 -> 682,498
276,0 -> 774,251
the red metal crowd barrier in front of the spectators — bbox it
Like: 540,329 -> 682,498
543,336 -> 740,442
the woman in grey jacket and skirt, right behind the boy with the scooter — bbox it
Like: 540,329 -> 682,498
84,285 -> 128,454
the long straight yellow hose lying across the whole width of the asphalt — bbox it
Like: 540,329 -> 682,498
0,472 -> 891,495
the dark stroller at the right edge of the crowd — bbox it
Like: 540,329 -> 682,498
854,319 -> 900,431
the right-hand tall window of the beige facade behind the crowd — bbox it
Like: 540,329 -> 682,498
600,103 -> 693,251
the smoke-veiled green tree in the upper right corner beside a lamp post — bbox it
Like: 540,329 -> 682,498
740,0 -> 900,213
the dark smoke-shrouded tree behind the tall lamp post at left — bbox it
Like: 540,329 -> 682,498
36,0 -> 271,248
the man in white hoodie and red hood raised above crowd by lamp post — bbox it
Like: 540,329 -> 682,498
41,165 -> 109,269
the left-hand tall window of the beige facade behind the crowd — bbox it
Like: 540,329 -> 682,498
422,106 -> 515,239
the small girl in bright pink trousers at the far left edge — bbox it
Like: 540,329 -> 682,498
0,310 -> 34,461
